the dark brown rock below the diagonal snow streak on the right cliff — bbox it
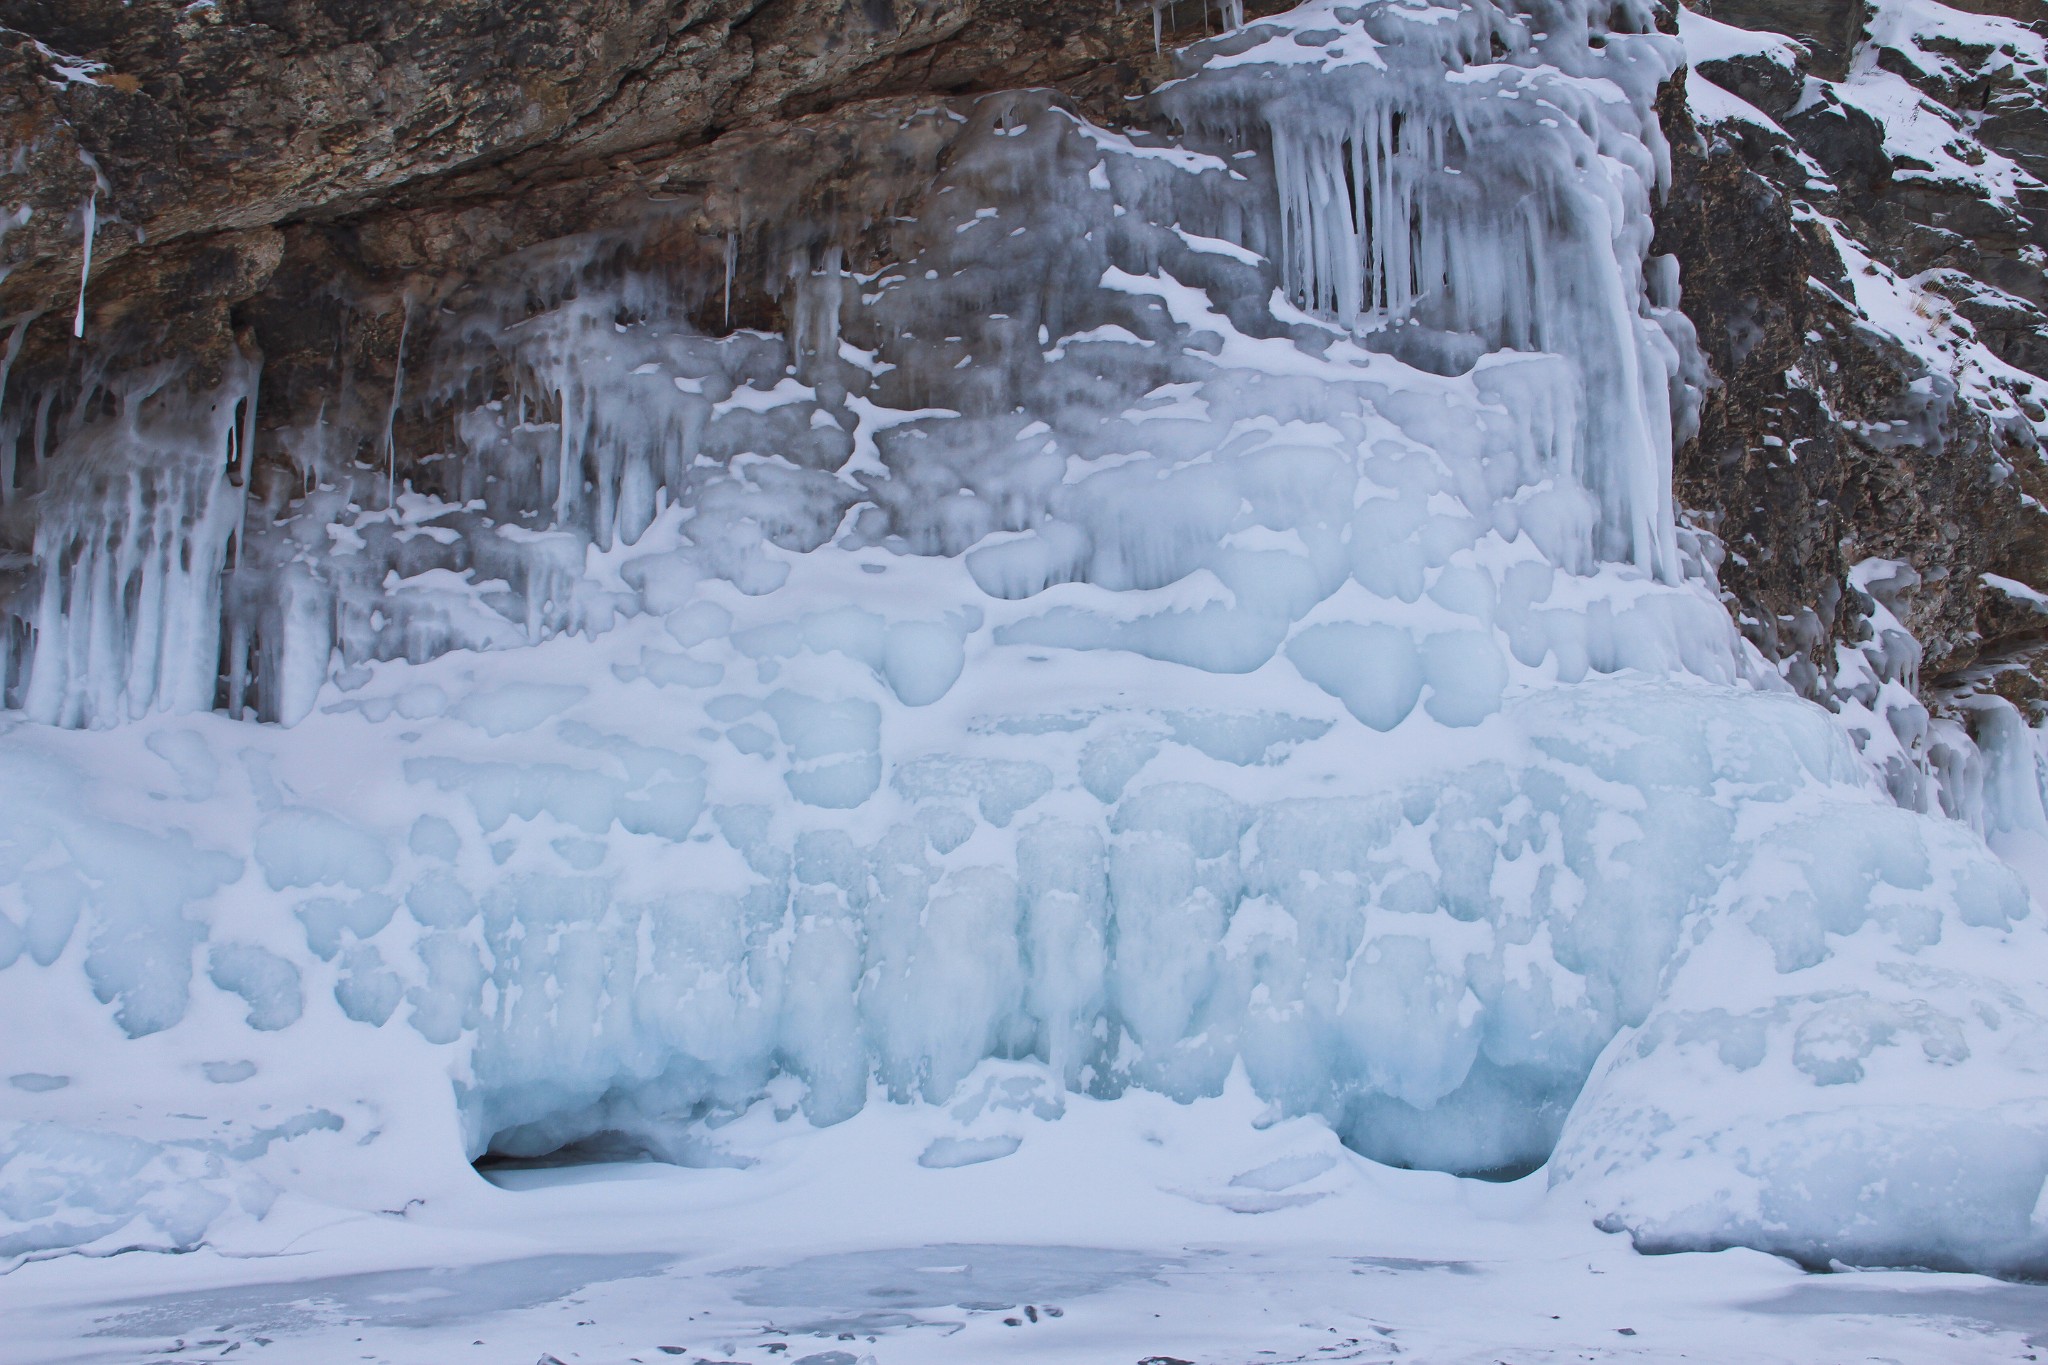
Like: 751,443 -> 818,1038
1657,90 -> 2048,686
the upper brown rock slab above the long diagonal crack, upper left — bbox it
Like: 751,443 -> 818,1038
0,0 -> 1171,297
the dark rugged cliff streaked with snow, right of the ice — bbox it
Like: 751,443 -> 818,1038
1657,0 -> 2048,724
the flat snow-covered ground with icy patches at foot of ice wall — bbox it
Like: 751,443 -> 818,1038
12,1068 -> 2048,1365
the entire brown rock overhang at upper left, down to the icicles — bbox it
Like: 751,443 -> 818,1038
0,0 -> 1196,386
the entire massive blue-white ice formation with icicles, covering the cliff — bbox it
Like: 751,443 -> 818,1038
0,0 -> 2048,1271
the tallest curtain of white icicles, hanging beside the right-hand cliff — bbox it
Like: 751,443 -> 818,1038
1165,4 -> 1690,579
